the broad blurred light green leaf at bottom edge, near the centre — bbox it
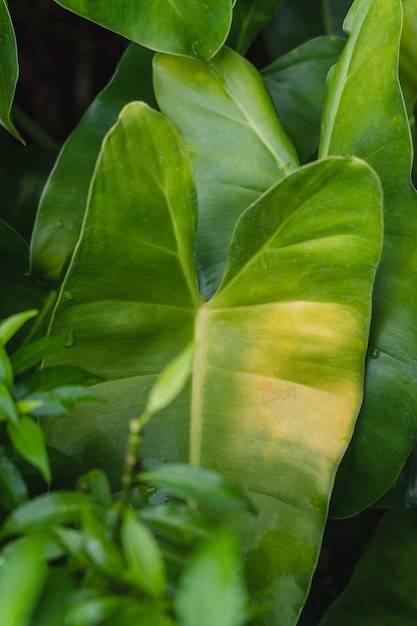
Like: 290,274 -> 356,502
175,529 -> 248,626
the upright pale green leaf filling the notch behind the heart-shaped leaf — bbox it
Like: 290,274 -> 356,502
154,48 -> 298,298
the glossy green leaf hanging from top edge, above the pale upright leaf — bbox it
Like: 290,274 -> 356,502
55,0 -> 232,59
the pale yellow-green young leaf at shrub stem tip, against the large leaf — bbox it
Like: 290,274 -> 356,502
146,343 -> 195,415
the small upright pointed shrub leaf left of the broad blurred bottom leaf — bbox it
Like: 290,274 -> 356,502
121,509 -> 165,597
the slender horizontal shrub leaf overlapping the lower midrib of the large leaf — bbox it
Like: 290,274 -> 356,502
139,463 -> 254,512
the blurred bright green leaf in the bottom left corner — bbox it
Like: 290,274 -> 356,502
0,535 -> 50,626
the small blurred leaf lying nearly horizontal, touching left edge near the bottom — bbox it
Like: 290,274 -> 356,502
0,491 -> 91,539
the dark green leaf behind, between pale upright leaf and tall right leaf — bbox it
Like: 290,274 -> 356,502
262,37 -> 345,163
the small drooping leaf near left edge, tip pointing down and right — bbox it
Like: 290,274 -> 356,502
7,417 -> 52,483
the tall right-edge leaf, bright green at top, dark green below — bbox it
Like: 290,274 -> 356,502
320,0 -> 417,516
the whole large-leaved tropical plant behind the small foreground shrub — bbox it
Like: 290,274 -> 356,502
0,0 -> 417,626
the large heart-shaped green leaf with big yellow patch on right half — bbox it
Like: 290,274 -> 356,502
45,103 -> 382,626
